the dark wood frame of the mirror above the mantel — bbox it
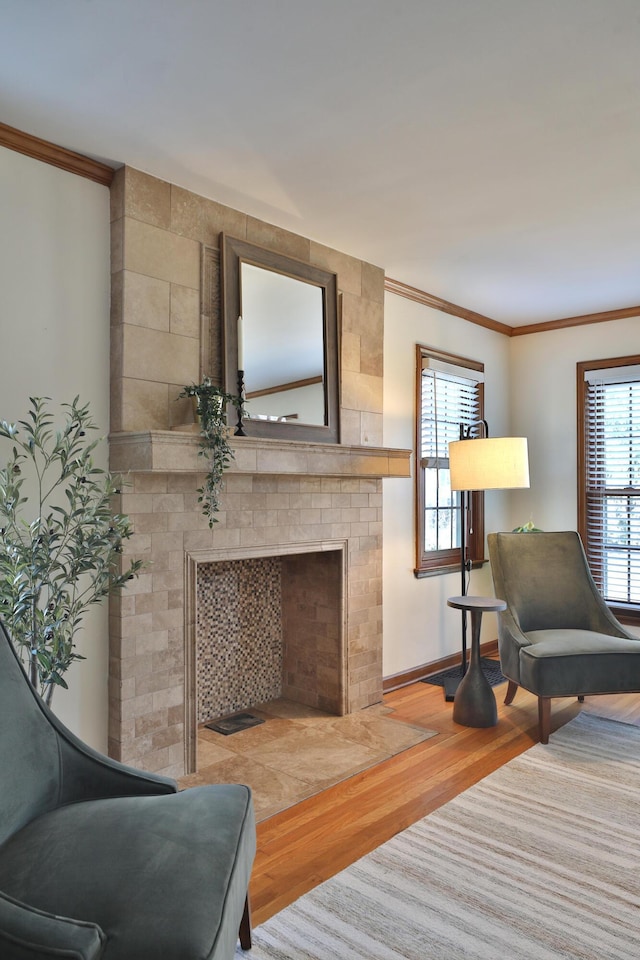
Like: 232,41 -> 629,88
220,234 -> 340,443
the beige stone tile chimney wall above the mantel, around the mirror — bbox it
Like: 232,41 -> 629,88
111,167 -> 384,446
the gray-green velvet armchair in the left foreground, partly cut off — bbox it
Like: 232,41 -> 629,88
0,624 -> 256,960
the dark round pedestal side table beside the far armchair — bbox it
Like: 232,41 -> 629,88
447,597 -> 507,727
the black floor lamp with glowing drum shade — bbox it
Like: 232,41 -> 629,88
445,420 -> 529,700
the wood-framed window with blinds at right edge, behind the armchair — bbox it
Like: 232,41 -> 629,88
578,357 -> 640,621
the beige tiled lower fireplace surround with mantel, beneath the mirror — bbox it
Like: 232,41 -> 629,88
110,431 -> 408,776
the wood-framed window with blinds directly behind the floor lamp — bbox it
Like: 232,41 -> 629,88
415,344 -> 484,576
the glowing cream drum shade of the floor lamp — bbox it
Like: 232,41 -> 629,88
449,437 -> 529,490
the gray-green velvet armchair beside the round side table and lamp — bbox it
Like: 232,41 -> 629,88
487,531 -> 640,743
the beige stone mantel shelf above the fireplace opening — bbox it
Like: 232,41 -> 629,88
109,430 -> 411,479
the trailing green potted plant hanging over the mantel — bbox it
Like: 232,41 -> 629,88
179,377 -> 242,527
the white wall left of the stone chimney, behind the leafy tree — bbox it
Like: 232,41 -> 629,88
0,147 -> 110,750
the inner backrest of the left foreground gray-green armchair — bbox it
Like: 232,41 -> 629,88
0,623 -> 60,843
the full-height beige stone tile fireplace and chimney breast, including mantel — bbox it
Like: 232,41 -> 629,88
109,168 -> 410,777
